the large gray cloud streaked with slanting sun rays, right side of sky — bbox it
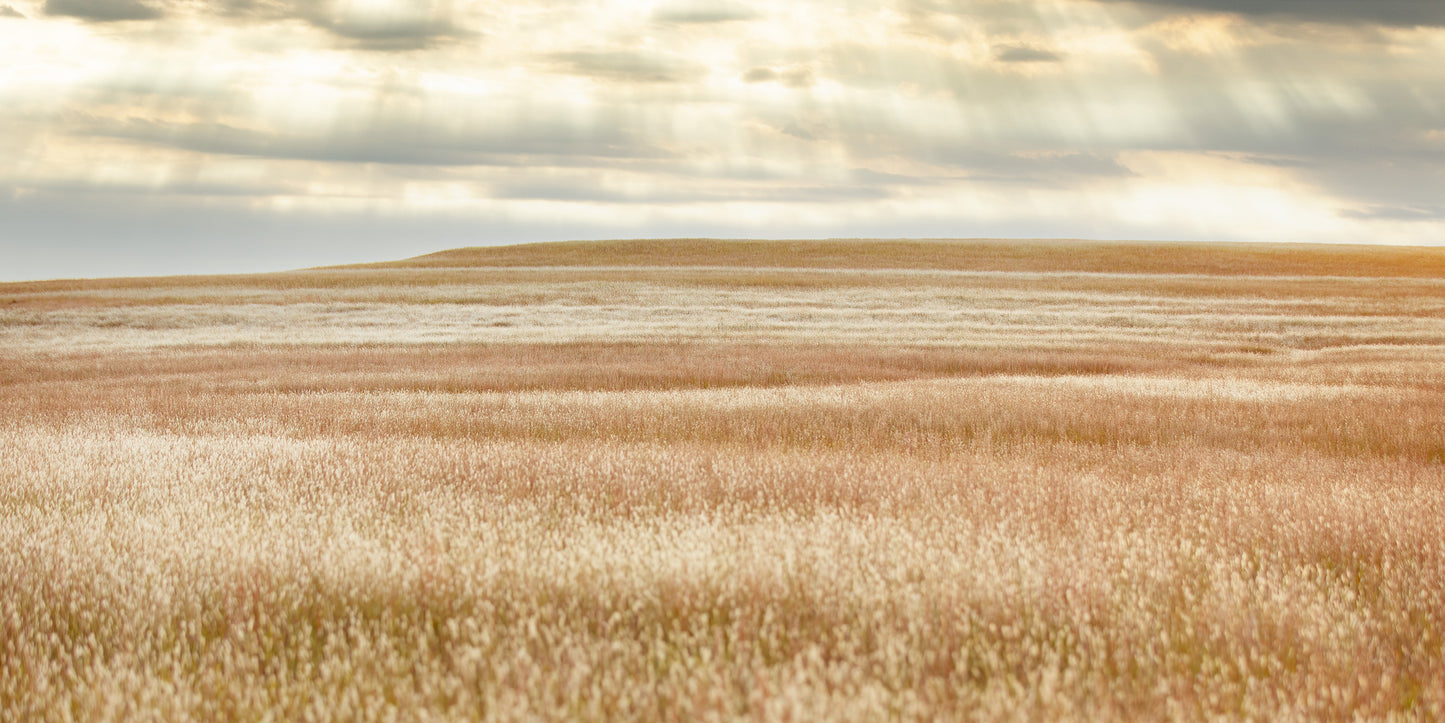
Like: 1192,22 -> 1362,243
803,32 -> 1445,220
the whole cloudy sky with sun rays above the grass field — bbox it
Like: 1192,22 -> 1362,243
0,0 -> 1445,281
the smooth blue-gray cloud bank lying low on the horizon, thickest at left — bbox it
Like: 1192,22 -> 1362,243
0,185 -> 1231,281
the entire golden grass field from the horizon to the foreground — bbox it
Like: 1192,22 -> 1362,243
0,241 -> 1445,720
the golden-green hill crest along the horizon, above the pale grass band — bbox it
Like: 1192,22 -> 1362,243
8,239 -> 1445,303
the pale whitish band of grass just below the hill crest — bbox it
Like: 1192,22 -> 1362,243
0,268 -> 1445,359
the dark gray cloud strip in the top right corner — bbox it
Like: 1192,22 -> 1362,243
1103,0 -> 1445,27
